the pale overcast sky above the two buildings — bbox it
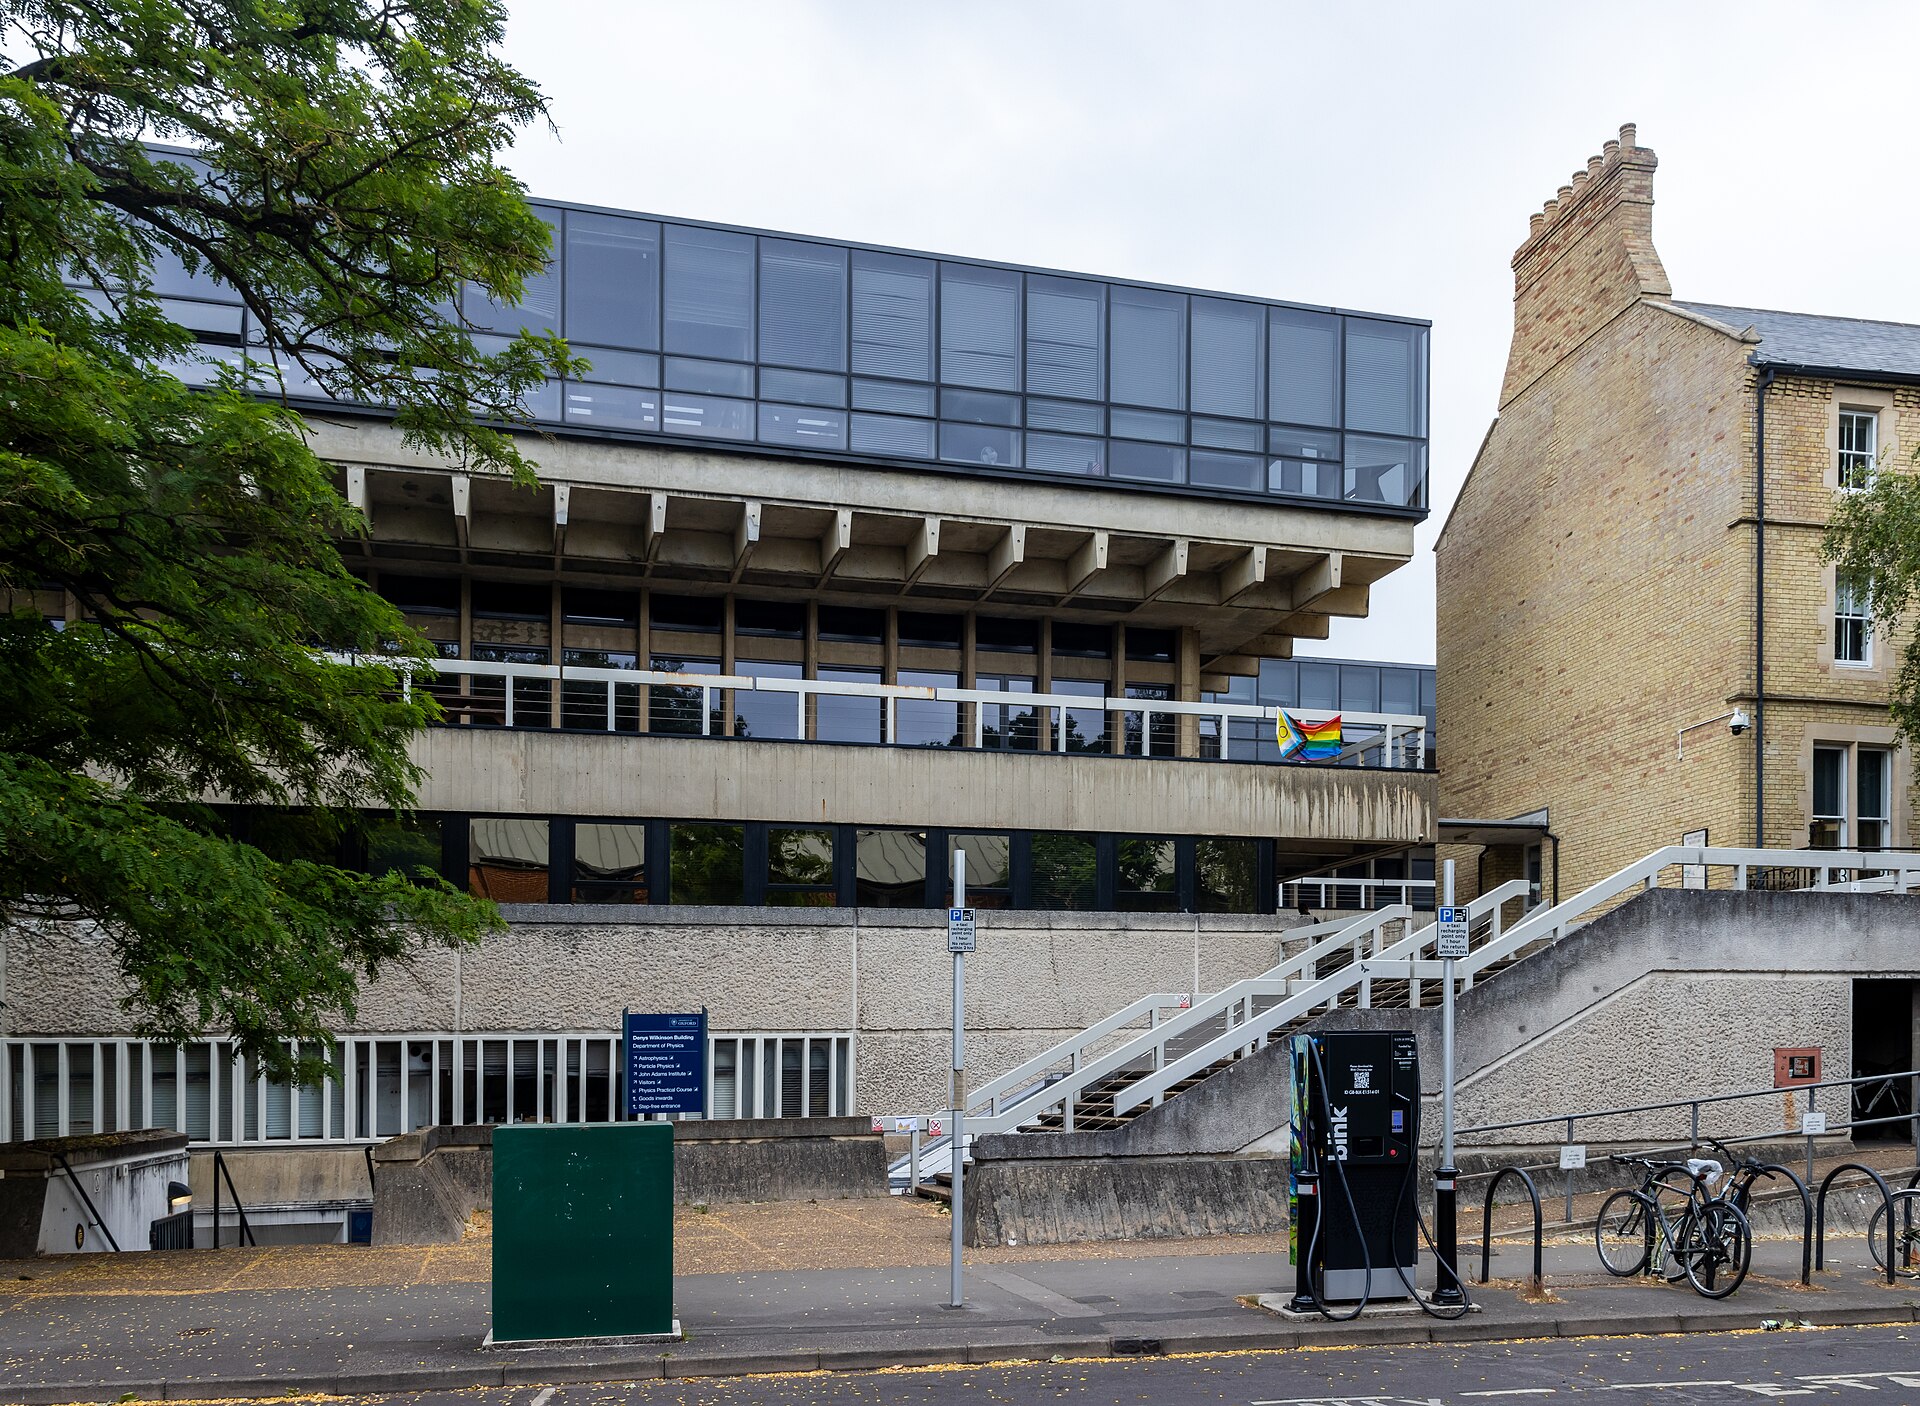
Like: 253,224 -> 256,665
507,0 -> 1920,663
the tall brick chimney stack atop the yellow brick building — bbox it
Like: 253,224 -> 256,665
1500,123 -> 1672,405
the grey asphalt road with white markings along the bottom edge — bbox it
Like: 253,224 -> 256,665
153,1327 -> 1920,1406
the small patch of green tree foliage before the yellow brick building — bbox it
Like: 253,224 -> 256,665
1820,453 -> 1920,747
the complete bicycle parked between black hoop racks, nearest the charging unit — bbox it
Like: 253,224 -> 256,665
1594,1152 -> 1753,1298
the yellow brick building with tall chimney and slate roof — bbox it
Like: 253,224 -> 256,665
1434,127 -> 1920,899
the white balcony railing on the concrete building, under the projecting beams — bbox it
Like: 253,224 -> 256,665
328,655 -> 1427,770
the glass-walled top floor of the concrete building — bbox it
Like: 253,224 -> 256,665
145,194 -> 1427,511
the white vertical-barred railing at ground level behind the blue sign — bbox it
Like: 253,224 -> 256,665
0,1031 -> 854,1147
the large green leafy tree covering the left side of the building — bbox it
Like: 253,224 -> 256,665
0,0 -> 566,1074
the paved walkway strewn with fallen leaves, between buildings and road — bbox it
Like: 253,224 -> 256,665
0,1200 -> 1920,1402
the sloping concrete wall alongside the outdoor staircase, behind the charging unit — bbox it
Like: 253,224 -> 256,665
966,889 -> 1920,1245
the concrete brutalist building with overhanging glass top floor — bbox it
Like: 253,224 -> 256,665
0,189 -> 1434,1229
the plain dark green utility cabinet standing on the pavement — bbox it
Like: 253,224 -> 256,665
492,1124 -> 676,1343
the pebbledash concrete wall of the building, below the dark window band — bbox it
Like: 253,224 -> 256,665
0,905 -> 1304,1114
